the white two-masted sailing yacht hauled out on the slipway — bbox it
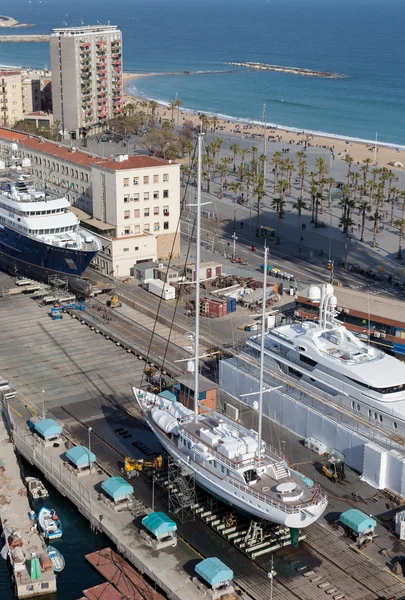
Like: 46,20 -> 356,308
133,134 -> 327,528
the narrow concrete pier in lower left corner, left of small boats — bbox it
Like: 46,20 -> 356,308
0,420 -> 56,598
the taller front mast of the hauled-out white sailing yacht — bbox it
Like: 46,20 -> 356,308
194,133 -> 204,418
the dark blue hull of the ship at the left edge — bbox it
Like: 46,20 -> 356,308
0,225 -> 97,282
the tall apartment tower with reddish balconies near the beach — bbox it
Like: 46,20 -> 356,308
51,25 -> 122,138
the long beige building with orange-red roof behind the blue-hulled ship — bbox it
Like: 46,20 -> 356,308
0,129 -> 180,277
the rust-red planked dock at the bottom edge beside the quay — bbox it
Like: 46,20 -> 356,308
85,548 -> 165,600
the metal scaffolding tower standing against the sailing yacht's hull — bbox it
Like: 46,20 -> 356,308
167,457 -> 197,523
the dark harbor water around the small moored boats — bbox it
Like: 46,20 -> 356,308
0,460 -> 112,600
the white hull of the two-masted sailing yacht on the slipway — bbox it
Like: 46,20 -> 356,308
146,418 -> 326,529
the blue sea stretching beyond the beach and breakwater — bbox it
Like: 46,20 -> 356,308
0,0 -> 405,145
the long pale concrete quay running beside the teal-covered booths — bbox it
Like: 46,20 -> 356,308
8,414 -> 208,600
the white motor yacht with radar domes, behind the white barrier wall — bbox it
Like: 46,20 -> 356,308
247,284 -> 405,433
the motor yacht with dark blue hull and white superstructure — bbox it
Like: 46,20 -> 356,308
0,177 -> 101,282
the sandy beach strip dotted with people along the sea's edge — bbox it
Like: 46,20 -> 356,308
123,73 -> 405,173
